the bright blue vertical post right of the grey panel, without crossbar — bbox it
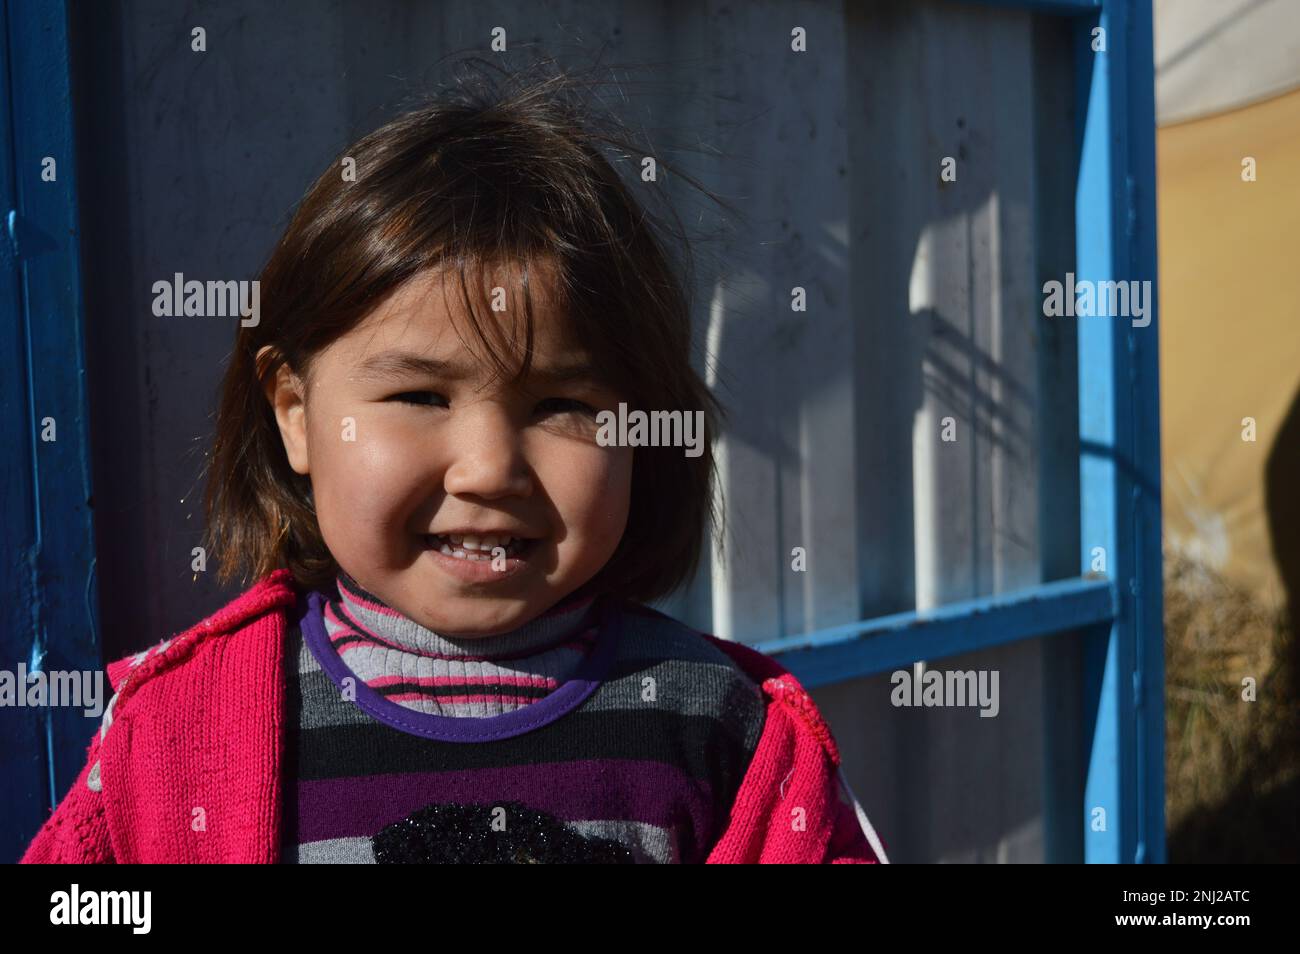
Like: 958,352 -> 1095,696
1075,0 -> 1166,863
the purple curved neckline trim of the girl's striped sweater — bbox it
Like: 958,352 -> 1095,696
299,590 -> 620,742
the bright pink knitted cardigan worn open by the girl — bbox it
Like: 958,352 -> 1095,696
22,569 -> 884,864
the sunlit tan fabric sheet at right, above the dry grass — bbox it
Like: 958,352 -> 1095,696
1157,83 -> 1300,597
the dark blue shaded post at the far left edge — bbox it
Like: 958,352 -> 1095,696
0,0 -> 101,860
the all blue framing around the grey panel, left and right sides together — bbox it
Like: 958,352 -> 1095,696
0,0 -> 1165,862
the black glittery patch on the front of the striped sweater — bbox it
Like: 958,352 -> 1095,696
371,802 -> 636,864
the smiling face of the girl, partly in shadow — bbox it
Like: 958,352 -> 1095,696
267,263 -> 633,637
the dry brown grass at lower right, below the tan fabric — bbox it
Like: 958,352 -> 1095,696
1165,552 -> 1300,862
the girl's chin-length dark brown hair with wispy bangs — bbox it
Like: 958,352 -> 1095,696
204,57 -> 729,602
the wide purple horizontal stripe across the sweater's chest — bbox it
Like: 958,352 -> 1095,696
298,759 -> 712,844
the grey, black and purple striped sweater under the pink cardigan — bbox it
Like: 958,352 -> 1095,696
282,582 -> 766,863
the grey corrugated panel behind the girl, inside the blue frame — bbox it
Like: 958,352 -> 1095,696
74,0 -> 1082,862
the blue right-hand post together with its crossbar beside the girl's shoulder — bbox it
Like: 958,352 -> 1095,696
758,0 -> 1166,863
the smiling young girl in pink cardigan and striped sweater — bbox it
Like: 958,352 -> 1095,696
25,72 -> 883,863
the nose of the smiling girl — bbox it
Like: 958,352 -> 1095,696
443,402 -> 533,500
